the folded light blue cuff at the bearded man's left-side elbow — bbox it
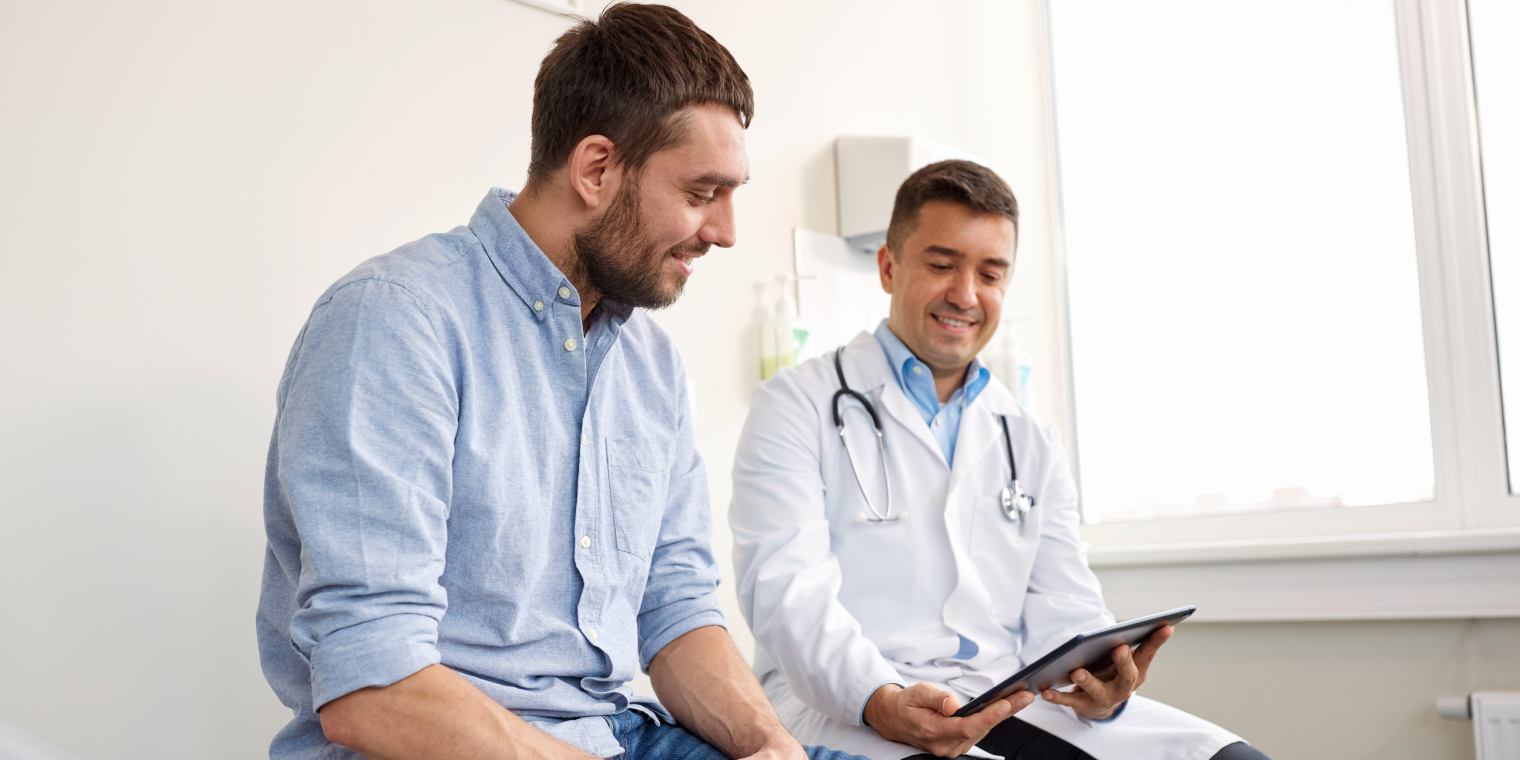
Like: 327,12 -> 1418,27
312,614 -> 442,710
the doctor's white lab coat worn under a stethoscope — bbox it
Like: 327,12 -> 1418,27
728,333 -> 1240,760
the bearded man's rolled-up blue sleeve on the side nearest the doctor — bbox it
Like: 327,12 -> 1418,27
638,363 -> 725,670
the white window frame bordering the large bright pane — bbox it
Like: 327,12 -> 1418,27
1040,0 -> 1520,567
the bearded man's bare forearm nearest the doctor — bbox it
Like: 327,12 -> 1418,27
649,626 -> 801,758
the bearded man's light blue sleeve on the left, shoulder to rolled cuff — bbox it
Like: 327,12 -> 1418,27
275,280 -> 458,708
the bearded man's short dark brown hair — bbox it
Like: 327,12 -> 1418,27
527,3 -> 755,182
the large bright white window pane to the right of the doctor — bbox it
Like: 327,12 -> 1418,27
1052,0 -> 1435,520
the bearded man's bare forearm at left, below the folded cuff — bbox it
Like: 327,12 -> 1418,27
321,664 -> 591,760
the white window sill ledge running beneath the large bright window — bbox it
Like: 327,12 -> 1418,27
1090,527 -> 1520,622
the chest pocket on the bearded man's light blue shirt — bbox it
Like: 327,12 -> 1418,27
606,438 -> 670,559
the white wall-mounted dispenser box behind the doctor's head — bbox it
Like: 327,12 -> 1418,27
834,135 -> 982,254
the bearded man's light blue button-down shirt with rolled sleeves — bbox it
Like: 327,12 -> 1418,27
257,190 -> 724,760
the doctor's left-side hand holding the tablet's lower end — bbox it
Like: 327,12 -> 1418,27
865,684 -> 1035,757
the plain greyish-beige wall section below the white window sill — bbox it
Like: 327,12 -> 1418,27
1142,620 -> 1520,760
